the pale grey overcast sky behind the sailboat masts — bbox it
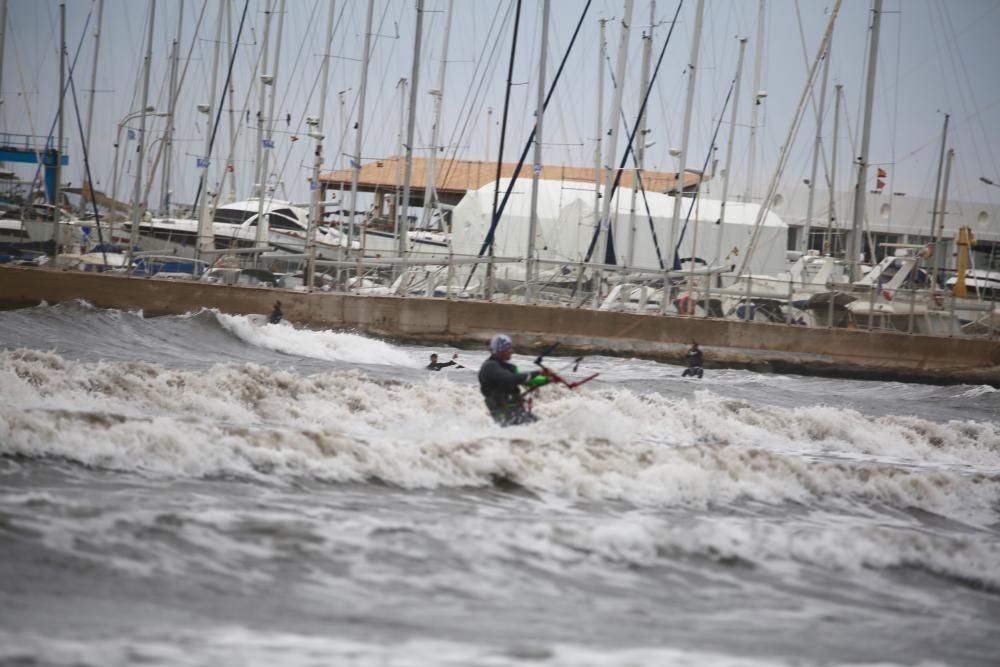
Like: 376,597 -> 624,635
0,0 -> 1000,214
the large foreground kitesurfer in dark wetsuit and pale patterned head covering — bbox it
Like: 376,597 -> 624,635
479,334 -> 552,426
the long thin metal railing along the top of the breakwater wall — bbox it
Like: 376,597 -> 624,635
39,235 -> 1000,339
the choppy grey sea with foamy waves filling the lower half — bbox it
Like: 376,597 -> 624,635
0,303 -> 1000,667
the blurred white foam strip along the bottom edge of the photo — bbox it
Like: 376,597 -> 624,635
0,625 -> 800,667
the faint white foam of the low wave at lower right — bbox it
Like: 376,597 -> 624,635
396,514 -> 1000,590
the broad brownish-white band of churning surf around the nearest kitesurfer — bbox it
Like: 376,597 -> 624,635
0,351 -> 1000,522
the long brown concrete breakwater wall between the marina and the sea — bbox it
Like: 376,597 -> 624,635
0,267 -> 1000,387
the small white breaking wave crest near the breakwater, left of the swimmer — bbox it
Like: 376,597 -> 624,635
216,313 -> 421,368
